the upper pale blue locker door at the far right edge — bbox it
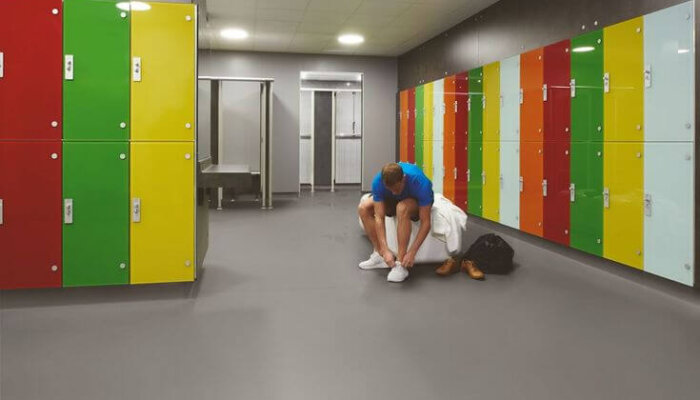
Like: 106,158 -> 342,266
644,1 -> 695,142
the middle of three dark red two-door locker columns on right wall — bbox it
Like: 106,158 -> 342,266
455,72 -> 469,211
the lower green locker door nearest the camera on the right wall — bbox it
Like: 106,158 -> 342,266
570,142 -> 603,256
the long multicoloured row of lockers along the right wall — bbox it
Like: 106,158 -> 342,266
400,3 -> 695,285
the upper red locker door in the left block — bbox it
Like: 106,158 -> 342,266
0,0 -> 63,140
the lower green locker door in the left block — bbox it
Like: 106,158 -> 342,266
63,142 -> 129,286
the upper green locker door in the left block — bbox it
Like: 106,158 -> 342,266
63,0 -> 130,141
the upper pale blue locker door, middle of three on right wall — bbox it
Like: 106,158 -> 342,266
500,56 -> 520,141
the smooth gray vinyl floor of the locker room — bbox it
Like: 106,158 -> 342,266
0,190 -> 700,400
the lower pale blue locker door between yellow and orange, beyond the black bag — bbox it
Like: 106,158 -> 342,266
499,140 -> 520,229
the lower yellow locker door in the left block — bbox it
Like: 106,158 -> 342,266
131,142 -> 195,284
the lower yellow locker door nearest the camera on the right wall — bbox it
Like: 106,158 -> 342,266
603,142 -> 644,269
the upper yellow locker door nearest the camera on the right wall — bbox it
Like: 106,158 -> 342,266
603,17 -> 644,142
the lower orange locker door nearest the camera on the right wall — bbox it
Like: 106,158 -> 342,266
520,141 -> 544,236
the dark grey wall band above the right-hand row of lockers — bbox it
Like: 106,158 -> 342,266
399,0 -> 685,89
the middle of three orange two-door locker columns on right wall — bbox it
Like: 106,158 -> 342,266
442,75 -> 457,203
